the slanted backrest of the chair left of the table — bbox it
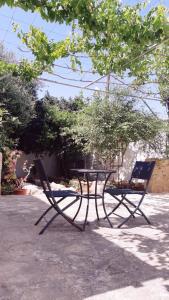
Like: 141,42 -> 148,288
34,159 -> 51,192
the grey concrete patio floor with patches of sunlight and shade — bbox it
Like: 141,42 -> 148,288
0,194 -> 169,300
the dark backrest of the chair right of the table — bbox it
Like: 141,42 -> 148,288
130,161 -> 155,185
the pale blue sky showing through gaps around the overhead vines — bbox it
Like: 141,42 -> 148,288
0,0 -> 169,117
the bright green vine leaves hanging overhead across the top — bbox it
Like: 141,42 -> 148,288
1,0 -> 169,82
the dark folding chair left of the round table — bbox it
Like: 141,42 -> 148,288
34,159 -> 83,234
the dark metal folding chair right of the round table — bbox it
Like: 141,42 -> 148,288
105,161 -> 155,228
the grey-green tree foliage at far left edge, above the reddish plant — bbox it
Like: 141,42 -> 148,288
0,44 -> 37,151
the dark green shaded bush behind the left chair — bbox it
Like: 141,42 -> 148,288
19,94 -> 84,157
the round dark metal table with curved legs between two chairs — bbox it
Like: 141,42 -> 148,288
70,169 -> 116,230
